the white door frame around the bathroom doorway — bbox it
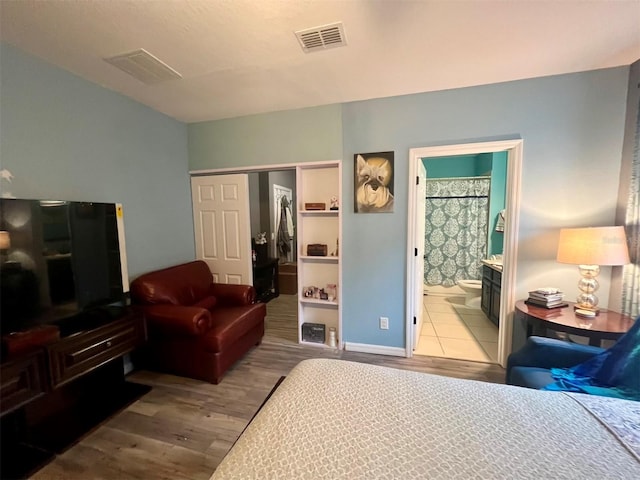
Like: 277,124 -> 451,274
405,139 -> 522,367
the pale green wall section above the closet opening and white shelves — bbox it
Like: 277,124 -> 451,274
189,105 -> 342,170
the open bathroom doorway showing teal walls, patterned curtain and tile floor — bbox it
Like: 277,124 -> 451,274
414,156 -> 507,363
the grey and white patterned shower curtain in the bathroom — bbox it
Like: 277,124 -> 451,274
424,177 -> 491,287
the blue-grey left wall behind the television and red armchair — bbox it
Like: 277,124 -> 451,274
0,43 -> 195,277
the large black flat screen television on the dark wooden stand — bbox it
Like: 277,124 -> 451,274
0,198 -> 128,335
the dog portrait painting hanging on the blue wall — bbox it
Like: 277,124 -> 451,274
353,152 -> 393,213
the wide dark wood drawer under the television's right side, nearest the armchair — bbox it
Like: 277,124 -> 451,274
48,317 -> 145,388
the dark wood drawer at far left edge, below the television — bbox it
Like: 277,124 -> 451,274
0,350 -> 47,415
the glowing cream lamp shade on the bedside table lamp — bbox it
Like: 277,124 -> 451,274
557,227 -> 629,265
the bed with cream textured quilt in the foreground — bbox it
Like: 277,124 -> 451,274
211,359 -> 640,480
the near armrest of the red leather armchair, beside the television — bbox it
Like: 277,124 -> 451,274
137,305 -> 212,336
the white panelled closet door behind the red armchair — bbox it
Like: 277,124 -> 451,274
191,174 -> 253,285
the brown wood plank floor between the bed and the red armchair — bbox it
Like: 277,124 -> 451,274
31,340 -> 504,480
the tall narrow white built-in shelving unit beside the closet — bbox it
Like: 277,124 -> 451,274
297,161 -> 343,348
